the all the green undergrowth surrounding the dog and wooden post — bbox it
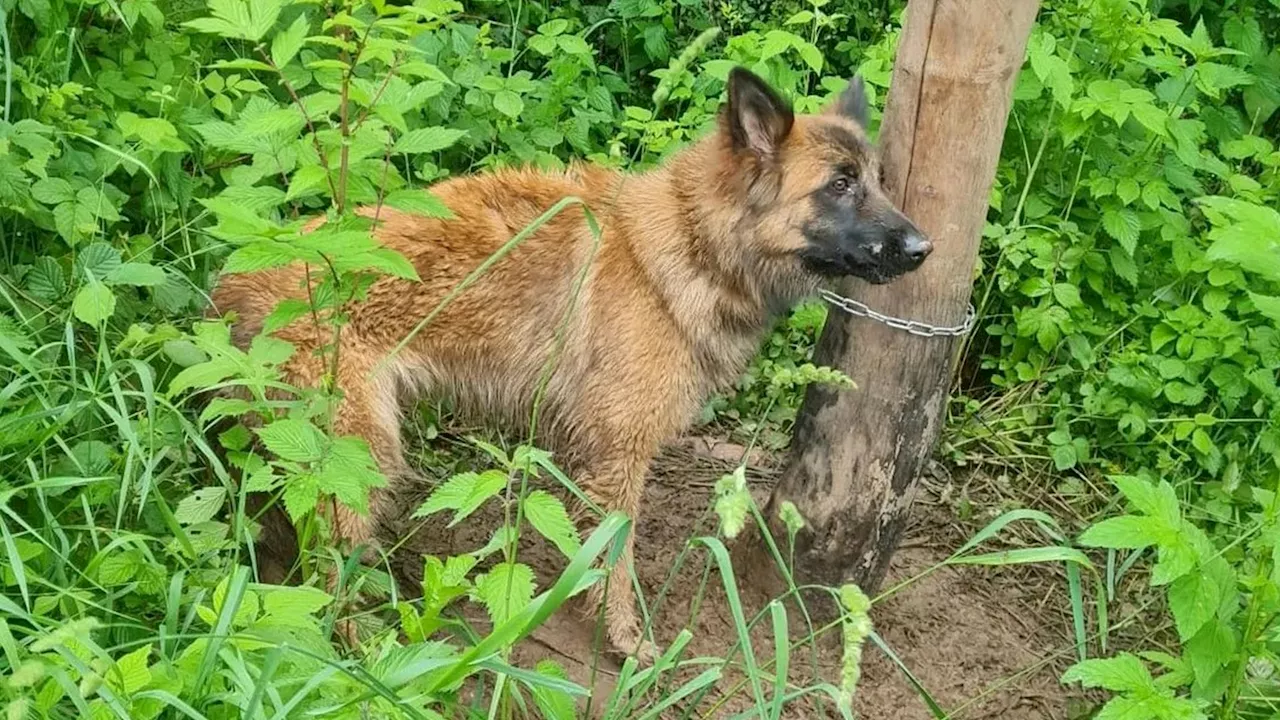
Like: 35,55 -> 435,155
0,0 -> 1280,719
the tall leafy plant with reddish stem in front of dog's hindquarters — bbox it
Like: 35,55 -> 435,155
169,0 -> 476,566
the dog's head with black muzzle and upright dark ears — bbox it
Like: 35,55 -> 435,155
721,68 -> 933,283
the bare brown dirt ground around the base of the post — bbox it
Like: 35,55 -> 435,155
384,438 -> 1079,720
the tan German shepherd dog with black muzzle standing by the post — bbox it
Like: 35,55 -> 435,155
212,68 -> 932,660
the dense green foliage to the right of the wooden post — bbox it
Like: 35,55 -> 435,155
926,0 -> 1280,717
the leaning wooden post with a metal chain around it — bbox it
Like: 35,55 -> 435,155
756,0 -> 1039,592
